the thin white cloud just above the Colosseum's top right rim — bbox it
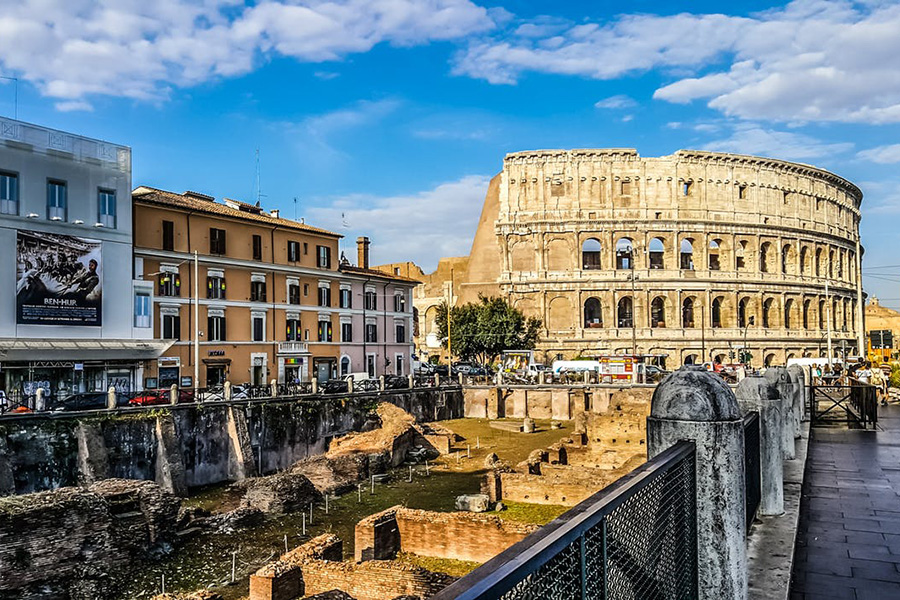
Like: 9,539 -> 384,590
703,123 -> 853,161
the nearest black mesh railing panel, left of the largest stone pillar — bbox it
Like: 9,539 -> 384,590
432,442 -> 697,600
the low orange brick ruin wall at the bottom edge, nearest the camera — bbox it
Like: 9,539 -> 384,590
250,534 -> 453,600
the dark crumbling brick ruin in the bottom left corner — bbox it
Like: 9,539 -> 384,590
0,479 -> 180,600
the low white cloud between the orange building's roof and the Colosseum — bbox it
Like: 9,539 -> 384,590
306,175 -> 490,272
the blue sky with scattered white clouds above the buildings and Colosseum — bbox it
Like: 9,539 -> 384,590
0,0 -> 900,307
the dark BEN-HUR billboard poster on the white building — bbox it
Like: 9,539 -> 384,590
16,230 -> 103,326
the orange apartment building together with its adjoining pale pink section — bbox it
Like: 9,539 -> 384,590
133,187 -> 415,388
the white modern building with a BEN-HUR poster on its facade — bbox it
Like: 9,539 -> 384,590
0,119 -> 170,398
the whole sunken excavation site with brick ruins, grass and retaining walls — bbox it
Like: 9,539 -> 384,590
0,387 -> 652,600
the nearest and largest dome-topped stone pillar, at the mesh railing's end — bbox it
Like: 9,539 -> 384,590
647,366 -> 747,600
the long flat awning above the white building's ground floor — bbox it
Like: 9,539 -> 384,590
0,338 -> 175,362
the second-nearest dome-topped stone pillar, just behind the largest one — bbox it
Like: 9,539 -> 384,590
735,375 -> 784,515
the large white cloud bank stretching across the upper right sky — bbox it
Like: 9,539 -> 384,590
454,0 -> 900,123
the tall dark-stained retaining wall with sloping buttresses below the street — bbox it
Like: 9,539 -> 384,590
0,387 -> 463,496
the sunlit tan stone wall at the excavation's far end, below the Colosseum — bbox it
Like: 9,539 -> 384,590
463,385 -> 655,421
